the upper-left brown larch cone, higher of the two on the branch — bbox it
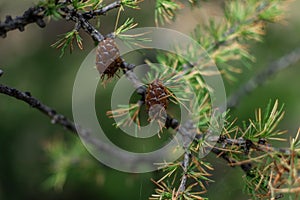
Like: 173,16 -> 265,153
96,38 -> 123,80
